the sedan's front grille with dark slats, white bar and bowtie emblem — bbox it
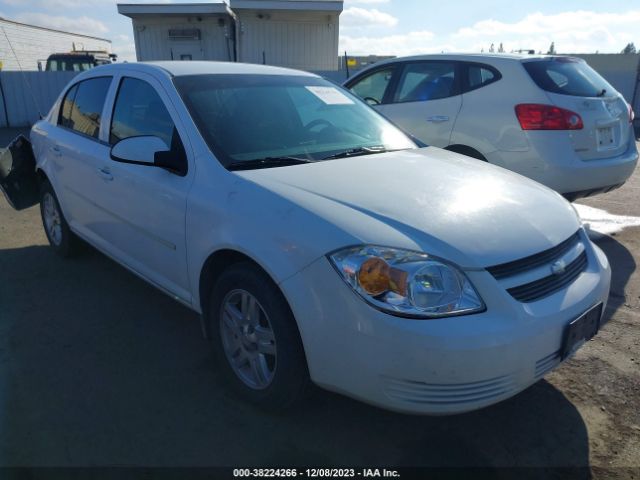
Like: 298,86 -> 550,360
487,231 -> 588,303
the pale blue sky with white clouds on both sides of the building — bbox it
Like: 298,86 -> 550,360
0,0 -> 640,60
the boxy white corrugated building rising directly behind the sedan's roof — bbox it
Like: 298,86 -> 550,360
118,0 -> 343,71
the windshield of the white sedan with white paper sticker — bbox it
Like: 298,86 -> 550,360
174,75 -> 416,168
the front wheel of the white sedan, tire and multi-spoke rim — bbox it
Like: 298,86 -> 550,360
207,262 -> 310,411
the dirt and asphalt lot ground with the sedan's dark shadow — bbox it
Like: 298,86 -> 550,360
0,141 -> 640,478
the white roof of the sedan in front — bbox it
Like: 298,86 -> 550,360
82,61 -> 317,77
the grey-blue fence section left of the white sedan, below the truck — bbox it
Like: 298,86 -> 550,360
0,72 -> 78,128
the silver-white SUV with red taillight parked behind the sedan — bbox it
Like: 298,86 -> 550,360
345,54 -> 638,199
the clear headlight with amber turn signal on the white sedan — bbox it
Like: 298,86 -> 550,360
329,245 -> 484,318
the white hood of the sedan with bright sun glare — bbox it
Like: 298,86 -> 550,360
236,147 -> 580,269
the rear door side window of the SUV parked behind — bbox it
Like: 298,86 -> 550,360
394,62 -> 458,103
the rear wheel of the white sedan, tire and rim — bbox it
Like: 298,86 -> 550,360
40,180 -> 80,258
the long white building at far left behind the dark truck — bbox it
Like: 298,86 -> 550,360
0,18 -> 111,71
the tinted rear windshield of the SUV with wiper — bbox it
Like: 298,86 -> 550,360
523,58 -> 614,97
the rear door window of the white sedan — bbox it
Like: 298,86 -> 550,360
58,77 -> 111,139
